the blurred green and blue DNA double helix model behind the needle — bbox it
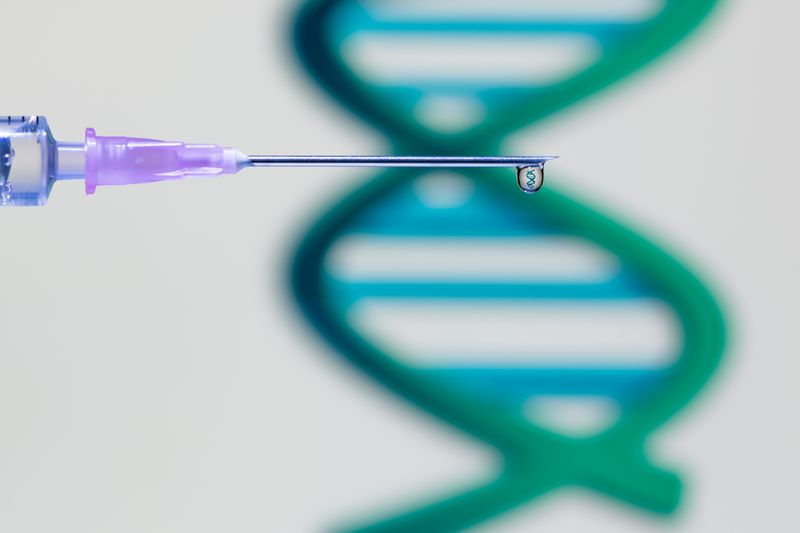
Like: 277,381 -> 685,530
291,0 -> 725,531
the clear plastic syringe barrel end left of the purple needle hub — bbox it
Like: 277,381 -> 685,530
0,116 -> 58,206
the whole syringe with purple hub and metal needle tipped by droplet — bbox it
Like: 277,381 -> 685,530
0,116 -> 554,205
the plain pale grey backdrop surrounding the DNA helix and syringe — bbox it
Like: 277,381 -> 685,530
0,0 -> 800,533
